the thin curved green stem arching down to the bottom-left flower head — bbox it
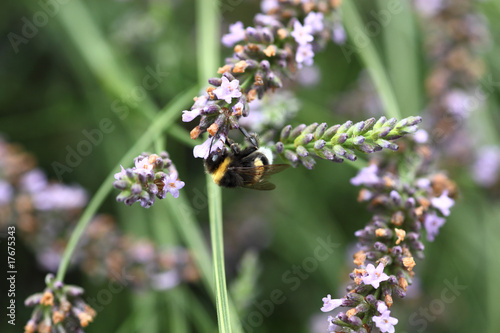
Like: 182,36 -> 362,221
57,87 -> 198,281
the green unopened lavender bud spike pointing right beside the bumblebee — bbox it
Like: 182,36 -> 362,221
275,117 -> 422,169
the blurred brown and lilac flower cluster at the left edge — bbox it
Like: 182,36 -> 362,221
0,137 -> 87,271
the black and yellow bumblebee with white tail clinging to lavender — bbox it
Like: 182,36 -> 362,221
205,143 -> 290,191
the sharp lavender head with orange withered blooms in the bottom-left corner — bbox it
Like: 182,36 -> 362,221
24,274 -> 97,333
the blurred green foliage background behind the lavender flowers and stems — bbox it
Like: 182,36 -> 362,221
0,0 -> 500,333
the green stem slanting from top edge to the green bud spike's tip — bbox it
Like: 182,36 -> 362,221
342,1 -> 401,119
